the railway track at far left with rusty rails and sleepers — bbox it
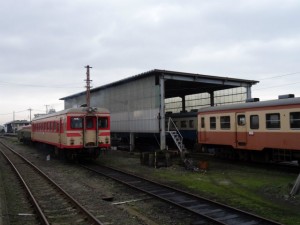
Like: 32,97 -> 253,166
0,141 -> 103,225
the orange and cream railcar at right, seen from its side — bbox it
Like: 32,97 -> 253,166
198,98 -> 300,161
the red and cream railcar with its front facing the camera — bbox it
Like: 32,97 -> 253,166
31,107 -> 110,157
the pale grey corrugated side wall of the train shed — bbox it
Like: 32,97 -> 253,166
65,76 -> 160,133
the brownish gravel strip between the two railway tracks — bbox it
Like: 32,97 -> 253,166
0,139 -> 211,225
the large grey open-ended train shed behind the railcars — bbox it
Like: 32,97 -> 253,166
60,69 -> 258,150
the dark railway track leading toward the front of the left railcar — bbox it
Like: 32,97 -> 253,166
82,165 -> 280,225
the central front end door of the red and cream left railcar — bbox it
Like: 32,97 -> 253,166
83,116 -> 98,148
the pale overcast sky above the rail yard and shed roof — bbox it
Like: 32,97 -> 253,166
0,0 -> 300,124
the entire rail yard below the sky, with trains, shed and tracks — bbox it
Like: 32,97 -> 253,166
0,69 -> 300,225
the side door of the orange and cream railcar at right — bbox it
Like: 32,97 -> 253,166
236,113 -> 247,148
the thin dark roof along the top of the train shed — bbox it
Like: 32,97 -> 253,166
60,69 -> 259,100
